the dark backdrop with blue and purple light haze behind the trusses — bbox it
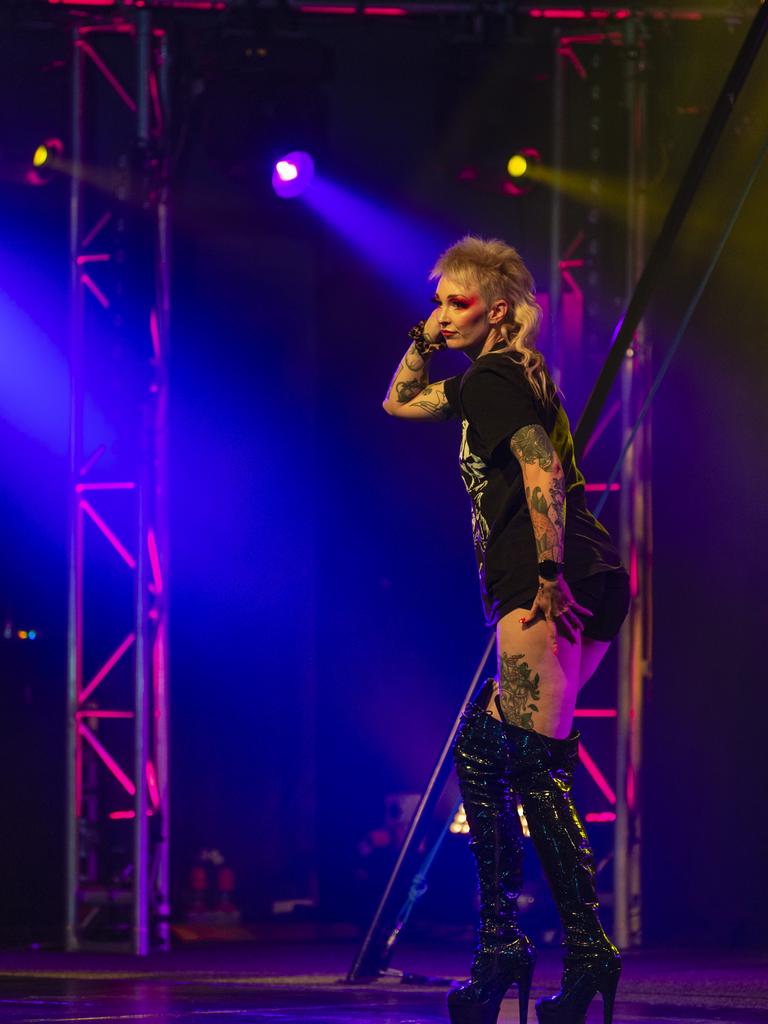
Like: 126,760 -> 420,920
0,6 -> 768,944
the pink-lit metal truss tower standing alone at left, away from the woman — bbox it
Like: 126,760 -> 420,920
66,8 -> 170,954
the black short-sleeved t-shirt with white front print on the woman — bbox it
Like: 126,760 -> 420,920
444,352 -> 622,626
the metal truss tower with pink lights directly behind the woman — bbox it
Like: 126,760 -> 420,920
550,18 -> 652,949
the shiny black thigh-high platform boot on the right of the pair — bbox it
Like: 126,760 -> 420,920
505,725 -> 622,1024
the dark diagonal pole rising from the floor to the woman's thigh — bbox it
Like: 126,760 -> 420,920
346,633 -> 496,981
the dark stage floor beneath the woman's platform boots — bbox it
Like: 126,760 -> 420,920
0,944 -> 768,1024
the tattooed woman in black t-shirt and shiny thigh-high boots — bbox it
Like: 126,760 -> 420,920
383,236 -> 629,1024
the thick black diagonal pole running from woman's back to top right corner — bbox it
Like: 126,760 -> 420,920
573,0 -> 768,458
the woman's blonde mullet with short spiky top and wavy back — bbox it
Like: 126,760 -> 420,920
429,234 -> 555,402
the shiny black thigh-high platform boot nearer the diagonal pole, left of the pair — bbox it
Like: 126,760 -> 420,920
447,680 -> 536,1024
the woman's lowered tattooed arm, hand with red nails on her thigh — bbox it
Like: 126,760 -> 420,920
510,424 -> 592,654
